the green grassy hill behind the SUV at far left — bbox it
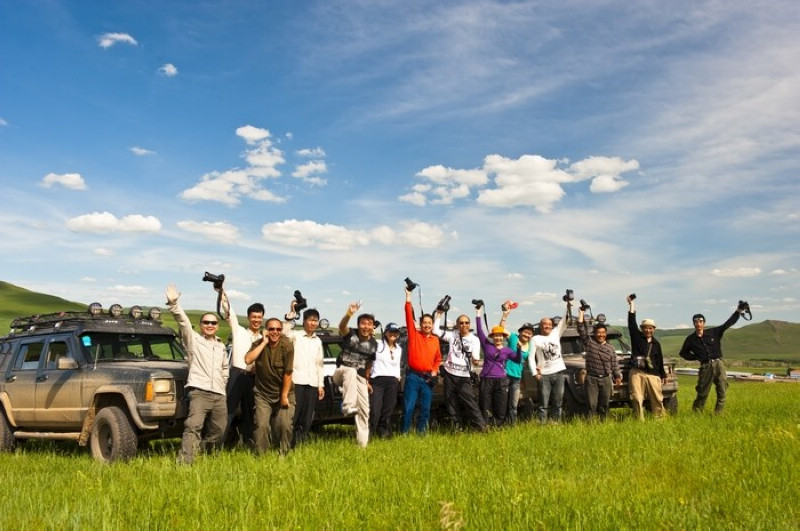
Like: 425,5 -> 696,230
0,281 -> 238,339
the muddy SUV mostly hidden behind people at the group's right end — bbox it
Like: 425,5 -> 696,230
519,314 -> 678,418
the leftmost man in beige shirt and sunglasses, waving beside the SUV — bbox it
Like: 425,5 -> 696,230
166,284 -> 229,465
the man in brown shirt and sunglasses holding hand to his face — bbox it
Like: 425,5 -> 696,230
244,317 -> 295,456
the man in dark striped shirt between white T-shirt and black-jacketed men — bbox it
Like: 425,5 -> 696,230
578,306 -> 622,420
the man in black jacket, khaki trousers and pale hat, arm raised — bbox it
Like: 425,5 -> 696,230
627,296 -> 667,420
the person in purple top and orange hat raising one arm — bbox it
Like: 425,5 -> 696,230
475,306 -> 520,426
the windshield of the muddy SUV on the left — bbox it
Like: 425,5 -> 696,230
81,332 -> 186,362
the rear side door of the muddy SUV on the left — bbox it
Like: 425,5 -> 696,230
5,338 -> 45,429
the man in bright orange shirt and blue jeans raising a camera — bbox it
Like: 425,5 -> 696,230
402,289 -> 442,433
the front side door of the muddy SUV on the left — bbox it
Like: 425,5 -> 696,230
36,335 -> 86,431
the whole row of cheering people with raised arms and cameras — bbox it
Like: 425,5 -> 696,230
166,285 -> 742,464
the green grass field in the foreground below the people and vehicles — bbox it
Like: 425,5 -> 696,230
0,377 -> 800,529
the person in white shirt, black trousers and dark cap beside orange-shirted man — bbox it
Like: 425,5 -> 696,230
369,323 -> 403,437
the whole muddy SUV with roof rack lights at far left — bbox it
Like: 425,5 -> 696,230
0,303 -> 188,462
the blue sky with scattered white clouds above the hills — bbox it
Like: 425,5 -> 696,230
0,0 -> 800,328
